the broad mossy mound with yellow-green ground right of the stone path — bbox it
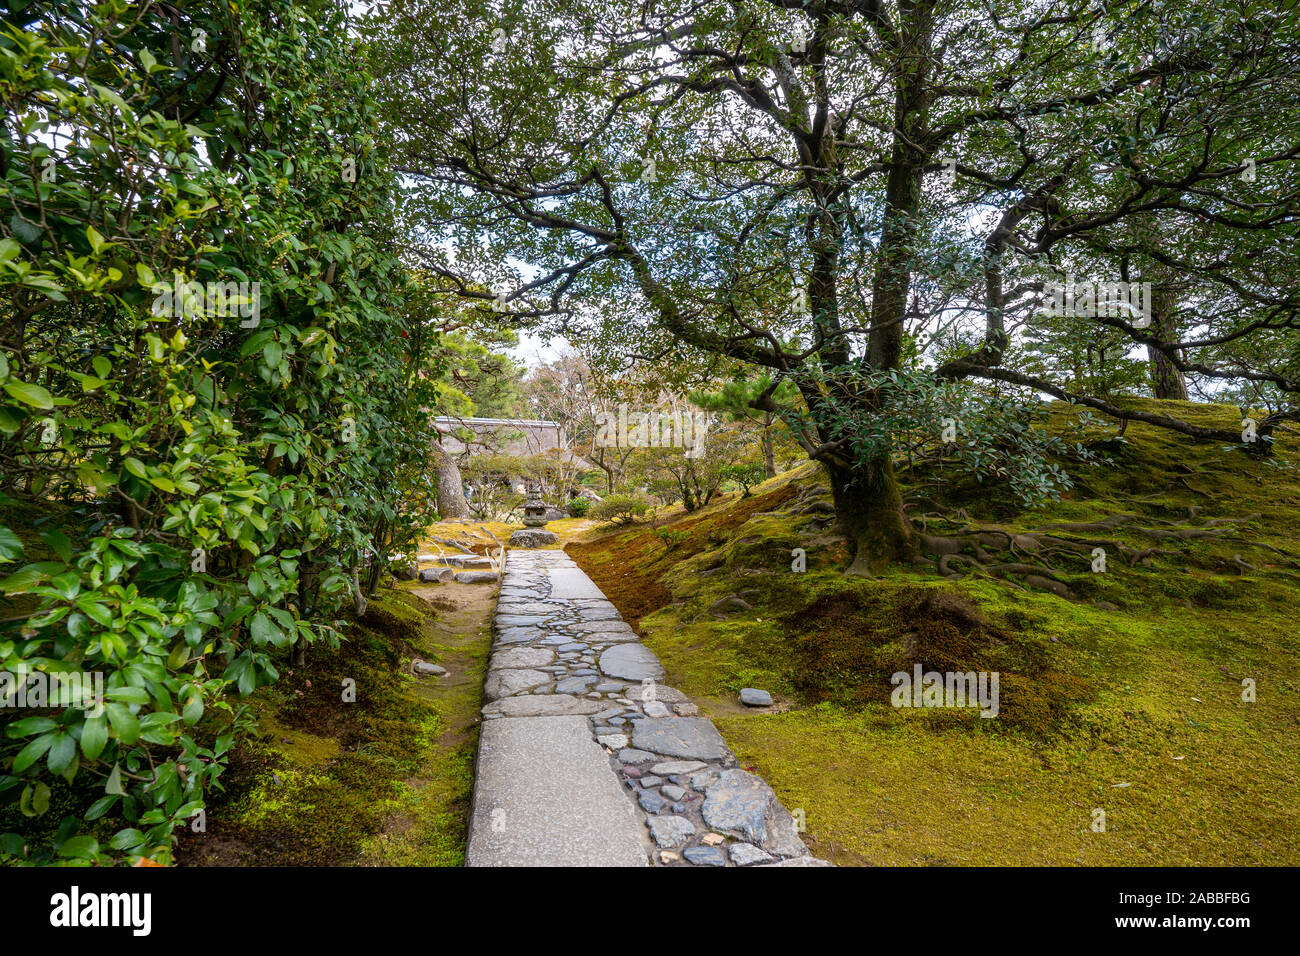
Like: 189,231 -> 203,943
568,402 -> 1300,865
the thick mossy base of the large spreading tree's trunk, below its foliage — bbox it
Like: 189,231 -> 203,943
827,454 -> 917,578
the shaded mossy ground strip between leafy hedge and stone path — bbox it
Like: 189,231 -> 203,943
177,530 -> 495,866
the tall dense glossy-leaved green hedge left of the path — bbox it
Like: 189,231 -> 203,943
0,0 -> 432,864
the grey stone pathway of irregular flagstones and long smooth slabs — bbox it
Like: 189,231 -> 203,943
465,550 -> 829,866
